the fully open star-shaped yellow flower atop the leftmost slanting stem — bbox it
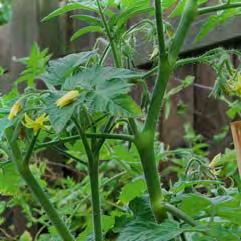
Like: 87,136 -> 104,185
23,113 -> 48,135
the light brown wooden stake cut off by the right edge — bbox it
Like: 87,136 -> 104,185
231,121 -> 241,177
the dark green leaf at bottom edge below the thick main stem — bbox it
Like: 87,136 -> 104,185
117,219 -> 183,241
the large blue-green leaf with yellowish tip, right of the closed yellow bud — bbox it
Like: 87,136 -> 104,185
63,67 -> 141,117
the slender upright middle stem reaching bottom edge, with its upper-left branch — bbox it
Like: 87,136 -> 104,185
73,119 -> 103,241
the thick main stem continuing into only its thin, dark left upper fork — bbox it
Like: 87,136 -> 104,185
135,0 -> 171,223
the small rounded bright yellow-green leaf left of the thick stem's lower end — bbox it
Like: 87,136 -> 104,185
119,179 -> 146,204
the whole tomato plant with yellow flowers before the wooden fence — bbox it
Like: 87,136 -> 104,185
0,0 -> 241,241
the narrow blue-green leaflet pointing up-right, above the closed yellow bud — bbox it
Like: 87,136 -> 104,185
41,51 -> 96,85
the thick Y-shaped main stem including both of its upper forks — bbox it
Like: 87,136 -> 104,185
135,0 -> 197,222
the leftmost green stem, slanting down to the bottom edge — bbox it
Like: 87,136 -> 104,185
5,129 -> 75,241
